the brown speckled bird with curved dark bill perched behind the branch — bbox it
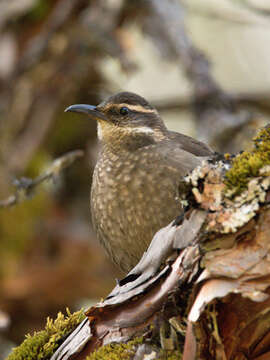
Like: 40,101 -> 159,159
65,91 -> 213,272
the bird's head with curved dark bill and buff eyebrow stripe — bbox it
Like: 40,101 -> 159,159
65,92 -> 167,149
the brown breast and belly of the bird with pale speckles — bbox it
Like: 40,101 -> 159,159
91,149 -> 181,271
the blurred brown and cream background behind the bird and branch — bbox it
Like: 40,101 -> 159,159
0,0 -> 270,359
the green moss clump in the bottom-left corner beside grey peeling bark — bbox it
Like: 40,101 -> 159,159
6,309 -> 85,360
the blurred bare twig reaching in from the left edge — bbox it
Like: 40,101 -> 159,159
0,150 -> 84,208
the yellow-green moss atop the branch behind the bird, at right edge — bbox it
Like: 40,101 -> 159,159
225,127 -> 270,195
